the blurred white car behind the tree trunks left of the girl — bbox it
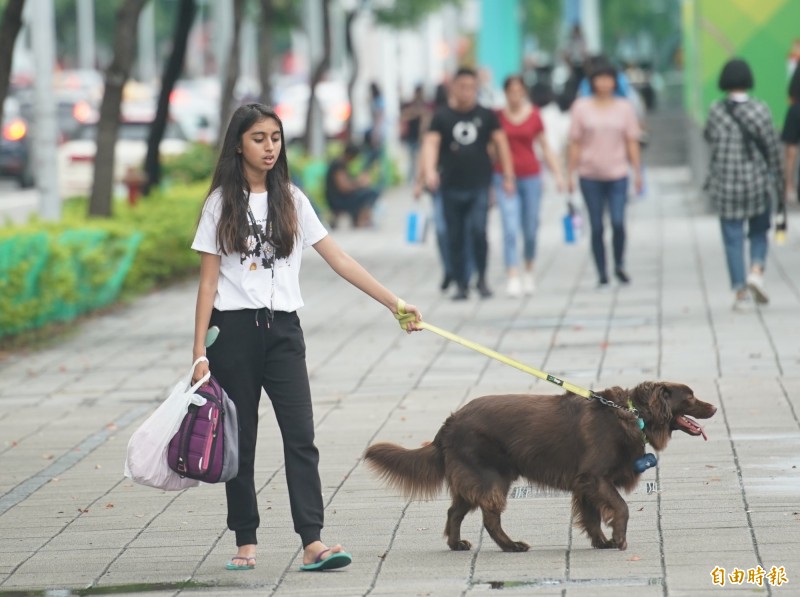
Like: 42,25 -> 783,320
58,111 -> 189,197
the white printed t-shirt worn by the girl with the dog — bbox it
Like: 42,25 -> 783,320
192,185 -> 328,313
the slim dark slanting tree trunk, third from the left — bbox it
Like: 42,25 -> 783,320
142,0 -> 197,195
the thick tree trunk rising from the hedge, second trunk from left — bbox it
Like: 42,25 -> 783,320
89,0 -> 147,217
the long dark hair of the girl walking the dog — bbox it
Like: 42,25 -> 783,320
203,104 -> 298,258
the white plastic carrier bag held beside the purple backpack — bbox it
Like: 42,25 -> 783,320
125,357 -> 211,491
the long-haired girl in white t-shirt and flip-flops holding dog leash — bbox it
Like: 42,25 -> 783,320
192,104 -> 422,570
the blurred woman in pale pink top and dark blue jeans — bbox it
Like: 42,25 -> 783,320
568,63 -> 642,288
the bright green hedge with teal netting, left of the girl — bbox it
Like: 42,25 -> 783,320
0,184 -> 207,338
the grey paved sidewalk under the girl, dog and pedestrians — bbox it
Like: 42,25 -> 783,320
0,161 -> 800,596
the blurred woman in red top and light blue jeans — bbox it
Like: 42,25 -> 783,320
494,75 -> 564,297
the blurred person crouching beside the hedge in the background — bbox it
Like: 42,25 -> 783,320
325,143 -> 380,228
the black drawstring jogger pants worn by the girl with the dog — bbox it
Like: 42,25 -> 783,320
206,309 -> 323,547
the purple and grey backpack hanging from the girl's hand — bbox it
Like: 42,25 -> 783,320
167,376 -> 239,483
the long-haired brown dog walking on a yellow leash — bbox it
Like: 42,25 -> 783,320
365,382 -> 717,551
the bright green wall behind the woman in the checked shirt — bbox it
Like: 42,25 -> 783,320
682,0 -> 800,126
